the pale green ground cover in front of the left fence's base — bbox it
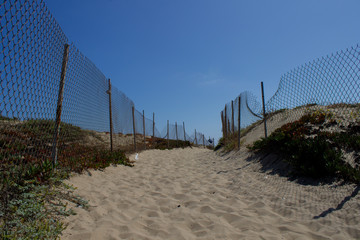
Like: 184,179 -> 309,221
0,164 -> 87,239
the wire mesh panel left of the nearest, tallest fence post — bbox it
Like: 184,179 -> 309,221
0,1 -> 68,161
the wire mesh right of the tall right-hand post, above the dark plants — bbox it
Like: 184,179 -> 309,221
265,45 -> 360,134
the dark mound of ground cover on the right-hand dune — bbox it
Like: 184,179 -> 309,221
250,110 -> 360,183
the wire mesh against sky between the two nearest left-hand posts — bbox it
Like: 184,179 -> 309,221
61,45 -> 109,132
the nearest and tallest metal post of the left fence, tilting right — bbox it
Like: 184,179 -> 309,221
52,44 -> 70,168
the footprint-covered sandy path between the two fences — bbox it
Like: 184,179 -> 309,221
62,148 -> 360,239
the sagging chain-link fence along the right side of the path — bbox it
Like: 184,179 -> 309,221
221,45 -> 360,178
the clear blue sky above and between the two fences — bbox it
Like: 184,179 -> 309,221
45,0 -> 360,142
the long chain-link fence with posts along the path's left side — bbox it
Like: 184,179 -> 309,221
0,0 -> 210,169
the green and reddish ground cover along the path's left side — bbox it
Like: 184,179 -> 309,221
0,119 -> 133,239
